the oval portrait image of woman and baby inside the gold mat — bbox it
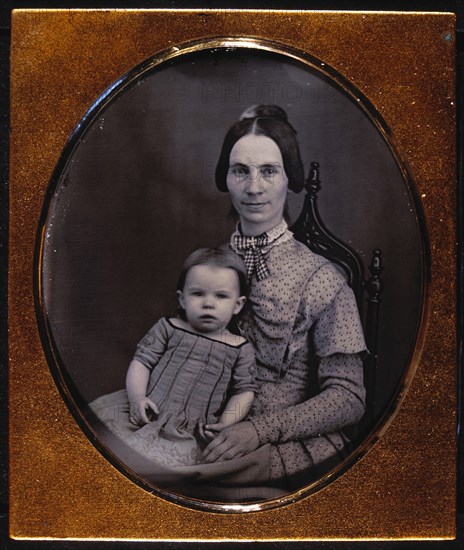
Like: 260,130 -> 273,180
40,43 -> 427,502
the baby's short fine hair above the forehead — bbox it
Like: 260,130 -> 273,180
177,247 -> 248,296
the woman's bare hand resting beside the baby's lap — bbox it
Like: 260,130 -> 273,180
202,422 -> 259,462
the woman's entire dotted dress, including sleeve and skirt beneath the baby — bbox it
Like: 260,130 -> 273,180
89,226 -> 366,501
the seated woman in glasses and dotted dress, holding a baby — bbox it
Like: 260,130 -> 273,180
204,105 -> 366,489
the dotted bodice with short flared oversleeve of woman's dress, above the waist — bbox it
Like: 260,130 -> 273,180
240,239 -> 365,381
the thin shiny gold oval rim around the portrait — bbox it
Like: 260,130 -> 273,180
35,37 -> 430,513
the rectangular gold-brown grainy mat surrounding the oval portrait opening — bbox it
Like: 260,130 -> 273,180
10,10 -> 456,541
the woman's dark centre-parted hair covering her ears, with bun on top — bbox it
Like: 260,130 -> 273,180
216,105 -> 304,193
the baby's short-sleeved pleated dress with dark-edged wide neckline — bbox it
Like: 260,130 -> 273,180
90,318 -> 256,467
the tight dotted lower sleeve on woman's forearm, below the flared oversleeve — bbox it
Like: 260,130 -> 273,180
249,354 -> 365,445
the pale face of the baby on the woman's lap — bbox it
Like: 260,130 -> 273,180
178,265 -> 245,335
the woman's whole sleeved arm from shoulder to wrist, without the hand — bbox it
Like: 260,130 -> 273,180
246,264 -> 366,444
